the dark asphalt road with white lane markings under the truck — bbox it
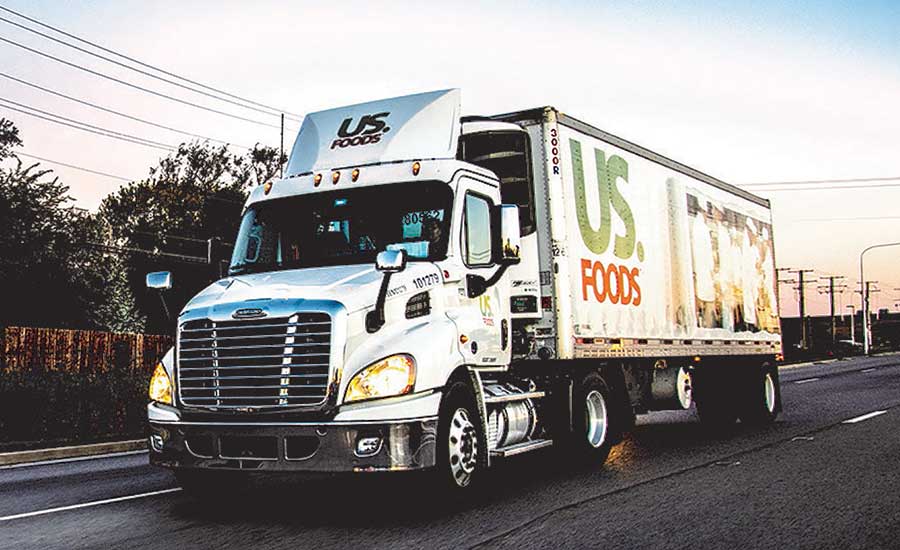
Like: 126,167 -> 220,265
0,356 -> 900,550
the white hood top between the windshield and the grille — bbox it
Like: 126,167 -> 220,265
182,262 -> 443,320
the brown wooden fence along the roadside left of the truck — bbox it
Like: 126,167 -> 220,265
0,327 -> 172,452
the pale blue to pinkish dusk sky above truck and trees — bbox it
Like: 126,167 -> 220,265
0,0 -> 900,315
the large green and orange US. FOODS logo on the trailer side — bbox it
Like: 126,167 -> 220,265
569,139 -> 644,306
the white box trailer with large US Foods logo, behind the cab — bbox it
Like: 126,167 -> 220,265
483,107 -> 781,359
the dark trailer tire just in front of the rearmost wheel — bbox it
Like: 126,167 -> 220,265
694,366 -> 739,435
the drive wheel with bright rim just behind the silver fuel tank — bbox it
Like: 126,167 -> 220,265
567,372 -> 626,465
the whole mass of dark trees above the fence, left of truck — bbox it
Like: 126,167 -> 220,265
0,119 -> 283,332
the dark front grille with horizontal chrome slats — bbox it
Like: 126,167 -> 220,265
178,313 -> 331,408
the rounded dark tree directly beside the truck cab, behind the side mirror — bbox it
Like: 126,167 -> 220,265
98,142 -> 284,331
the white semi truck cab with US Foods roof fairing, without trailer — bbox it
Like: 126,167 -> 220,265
148,90 -> 537,492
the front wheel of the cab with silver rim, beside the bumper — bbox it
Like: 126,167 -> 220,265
434,382 -> 488,495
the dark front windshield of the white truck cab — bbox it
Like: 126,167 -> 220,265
229,182 -> 453,275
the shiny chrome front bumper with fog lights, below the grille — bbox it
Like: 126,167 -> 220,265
149,417 -> 437,473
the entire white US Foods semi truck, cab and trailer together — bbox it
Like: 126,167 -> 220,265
148,90 -> 781,493
